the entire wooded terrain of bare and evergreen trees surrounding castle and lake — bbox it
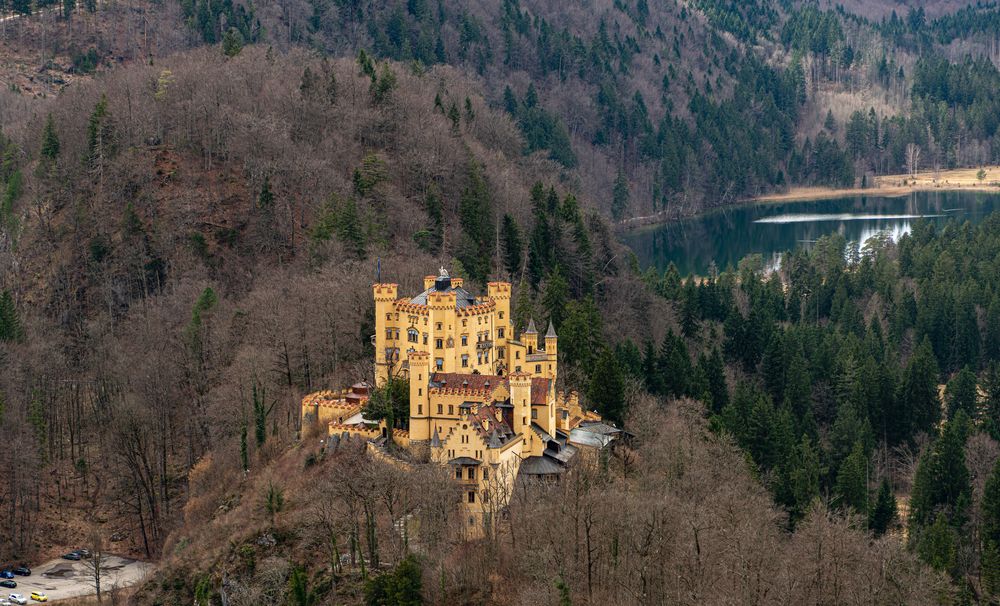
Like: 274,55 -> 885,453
0,0 -> 1000,604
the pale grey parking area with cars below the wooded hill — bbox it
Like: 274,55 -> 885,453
0,556 -> 155,600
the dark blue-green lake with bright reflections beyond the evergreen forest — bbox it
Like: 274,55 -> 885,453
621,191 -> 1000,275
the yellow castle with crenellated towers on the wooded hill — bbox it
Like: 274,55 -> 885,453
302,268 -> 620,526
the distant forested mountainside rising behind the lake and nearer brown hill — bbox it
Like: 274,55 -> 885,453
5,0 -> 1000,219
